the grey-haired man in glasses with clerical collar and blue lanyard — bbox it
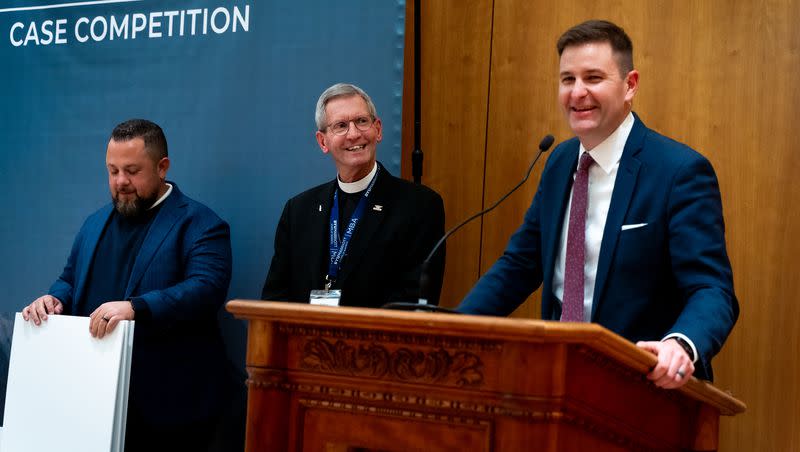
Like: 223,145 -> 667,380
261,83 -> 444,307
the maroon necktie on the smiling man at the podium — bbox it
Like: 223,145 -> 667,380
561,152 -> 594,322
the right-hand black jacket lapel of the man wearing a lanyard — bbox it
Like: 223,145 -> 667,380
332,166 -> 392,287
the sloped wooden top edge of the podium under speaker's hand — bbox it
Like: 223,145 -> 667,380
226,300 -> 746,416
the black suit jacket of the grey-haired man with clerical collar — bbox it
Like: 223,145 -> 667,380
261,164 -> 445,308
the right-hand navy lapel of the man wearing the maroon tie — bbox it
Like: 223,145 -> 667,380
592,115 -> 647,321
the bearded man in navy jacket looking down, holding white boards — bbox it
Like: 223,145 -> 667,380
22,119 -> 231,451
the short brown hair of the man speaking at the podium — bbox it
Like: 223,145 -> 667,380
556,20 -> 633,77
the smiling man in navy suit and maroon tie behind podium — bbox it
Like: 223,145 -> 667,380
458,21 -> 739,388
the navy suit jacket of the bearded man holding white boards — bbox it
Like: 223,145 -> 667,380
49,184 -> 231,425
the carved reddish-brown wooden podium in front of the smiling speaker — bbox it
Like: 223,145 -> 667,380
227,300 -> 745,452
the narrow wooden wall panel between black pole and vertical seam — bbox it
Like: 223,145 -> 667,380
403,0 -> 492,306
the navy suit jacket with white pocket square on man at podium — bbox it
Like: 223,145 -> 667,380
458,116 -> 739,380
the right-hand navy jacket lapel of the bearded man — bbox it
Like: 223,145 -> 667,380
125,184 -> 186,299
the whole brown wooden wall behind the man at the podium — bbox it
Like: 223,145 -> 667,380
406,0 -> 800,451
